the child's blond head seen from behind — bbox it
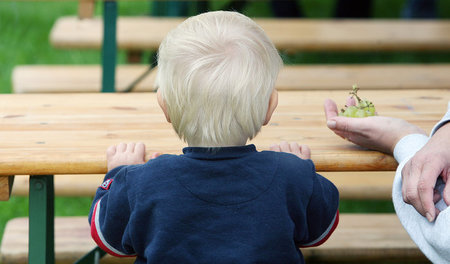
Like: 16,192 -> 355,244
156,11 -> 282,147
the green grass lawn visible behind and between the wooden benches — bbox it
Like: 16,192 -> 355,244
0,0 -> 450,262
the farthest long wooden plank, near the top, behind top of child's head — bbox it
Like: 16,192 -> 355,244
50,17 -> 450,51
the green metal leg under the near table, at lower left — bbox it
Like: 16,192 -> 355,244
28,175 -> 55,264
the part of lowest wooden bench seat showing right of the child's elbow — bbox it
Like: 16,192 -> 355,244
302,214 -> 427,263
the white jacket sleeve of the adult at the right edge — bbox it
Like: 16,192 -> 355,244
392,102 -> 450,264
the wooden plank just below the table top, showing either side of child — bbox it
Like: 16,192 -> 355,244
10,171 -> 394,200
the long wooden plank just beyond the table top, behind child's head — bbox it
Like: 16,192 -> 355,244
12,64 -> 450,93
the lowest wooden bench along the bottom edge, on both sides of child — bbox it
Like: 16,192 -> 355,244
0,214 -> 427,264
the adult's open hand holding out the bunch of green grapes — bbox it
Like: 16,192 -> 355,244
324,99 -> 425,154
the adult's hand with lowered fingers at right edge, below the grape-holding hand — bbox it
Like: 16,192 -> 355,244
402,123 -> 450,222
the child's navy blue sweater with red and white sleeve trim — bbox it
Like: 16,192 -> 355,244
89,145 -> 339,263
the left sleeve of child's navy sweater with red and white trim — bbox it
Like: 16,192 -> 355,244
89,166 -> 135,257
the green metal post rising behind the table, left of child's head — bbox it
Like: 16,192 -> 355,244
102,0 -> 117,93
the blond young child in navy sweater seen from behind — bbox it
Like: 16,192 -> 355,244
89,11 -> 339,263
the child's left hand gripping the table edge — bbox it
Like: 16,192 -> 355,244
106,143 -> 160,171
